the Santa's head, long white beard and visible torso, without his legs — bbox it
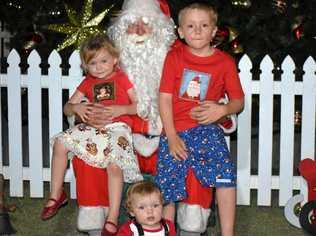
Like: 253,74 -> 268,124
107,0 -> 176,174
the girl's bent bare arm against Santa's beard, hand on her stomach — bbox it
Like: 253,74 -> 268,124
104,88 -> 137,119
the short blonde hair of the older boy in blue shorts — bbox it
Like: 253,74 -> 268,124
178,2 -> 218,26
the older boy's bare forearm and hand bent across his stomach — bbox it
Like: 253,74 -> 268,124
190,98 -> 244,124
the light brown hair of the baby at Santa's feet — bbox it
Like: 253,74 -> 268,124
125,180 -> 163,212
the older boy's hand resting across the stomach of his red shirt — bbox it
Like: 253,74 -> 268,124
190,101 -> 226,125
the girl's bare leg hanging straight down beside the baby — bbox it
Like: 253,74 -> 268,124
105,164 -> 123,232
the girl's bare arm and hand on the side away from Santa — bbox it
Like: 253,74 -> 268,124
64,90 -> 93,122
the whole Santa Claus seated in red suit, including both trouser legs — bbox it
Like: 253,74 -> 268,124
73,0 -> 235,235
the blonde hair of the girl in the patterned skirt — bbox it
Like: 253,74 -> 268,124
80,34 -> 119,70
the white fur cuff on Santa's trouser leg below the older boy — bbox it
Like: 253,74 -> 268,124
177,202 -> 211,233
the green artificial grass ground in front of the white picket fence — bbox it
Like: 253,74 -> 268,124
1,183 -> 308,236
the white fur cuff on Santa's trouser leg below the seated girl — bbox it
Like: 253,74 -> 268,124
77,206 -> 109,232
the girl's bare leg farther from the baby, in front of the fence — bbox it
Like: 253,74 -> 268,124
46,140 -> 68,206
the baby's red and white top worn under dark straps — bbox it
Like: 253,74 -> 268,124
117,220 -> 176,236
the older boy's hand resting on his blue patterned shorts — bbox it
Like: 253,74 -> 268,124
168,135 -> 188,161
